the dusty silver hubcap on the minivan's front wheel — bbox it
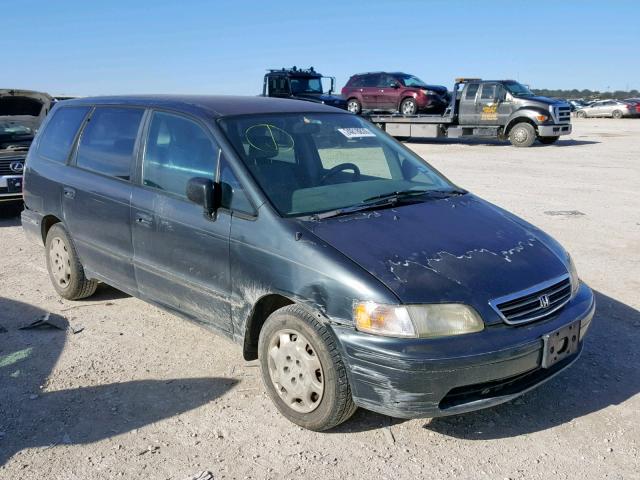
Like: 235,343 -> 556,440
268,329 -> 324,413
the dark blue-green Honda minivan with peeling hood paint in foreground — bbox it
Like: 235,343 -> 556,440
22,96 -> 595,430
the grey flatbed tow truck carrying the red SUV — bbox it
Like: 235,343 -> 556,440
365,78 -> 571,147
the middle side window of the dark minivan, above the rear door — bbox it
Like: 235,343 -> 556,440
76,107 -> 144,180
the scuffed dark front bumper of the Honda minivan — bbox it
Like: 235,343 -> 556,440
333,284 -> 595,418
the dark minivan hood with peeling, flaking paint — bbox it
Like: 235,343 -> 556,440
302,194 -> 567,318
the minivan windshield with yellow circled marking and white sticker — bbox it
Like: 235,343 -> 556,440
220,113 -> 455,217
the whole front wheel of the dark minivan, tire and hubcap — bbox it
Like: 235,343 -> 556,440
258,305 -> 357,431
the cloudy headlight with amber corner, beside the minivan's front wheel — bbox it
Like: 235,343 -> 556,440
353,302 -> 484,338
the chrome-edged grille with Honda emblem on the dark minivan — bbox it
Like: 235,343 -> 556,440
489,275 -> 571,325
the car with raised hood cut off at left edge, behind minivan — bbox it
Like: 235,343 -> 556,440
0,89 -> 53,215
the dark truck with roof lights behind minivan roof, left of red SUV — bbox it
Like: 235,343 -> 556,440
262,66 -> 347,110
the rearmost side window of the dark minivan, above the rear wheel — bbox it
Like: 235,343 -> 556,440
38,107 -> 89,163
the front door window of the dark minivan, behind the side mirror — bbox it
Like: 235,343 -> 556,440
142,112 -> 218,198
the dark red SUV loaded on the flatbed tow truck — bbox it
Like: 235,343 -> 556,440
342,72 -> 449,115
